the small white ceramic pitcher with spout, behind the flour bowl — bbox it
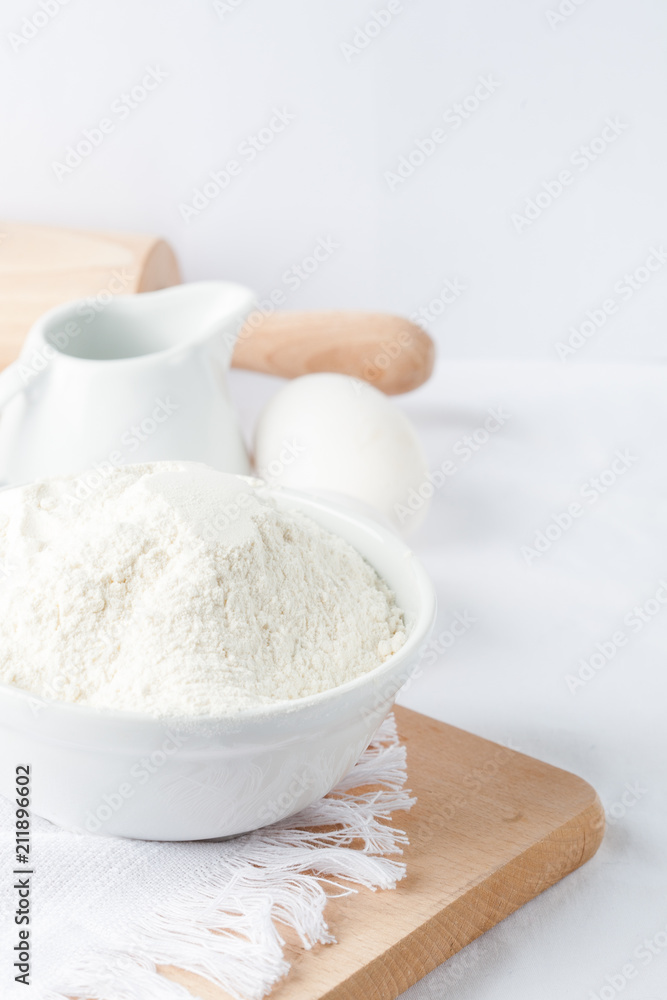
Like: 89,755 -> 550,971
0,281 -> 254,484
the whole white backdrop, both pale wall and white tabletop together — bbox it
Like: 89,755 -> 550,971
0,0 -> 667,1000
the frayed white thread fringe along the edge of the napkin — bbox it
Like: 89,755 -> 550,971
40,716 -> 415,1000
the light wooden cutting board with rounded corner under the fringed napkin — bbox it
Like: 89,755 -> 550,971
162,708 -> 604,1000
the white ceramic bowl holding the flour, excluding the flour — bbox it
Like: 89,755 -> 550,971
0,490 -> 435,840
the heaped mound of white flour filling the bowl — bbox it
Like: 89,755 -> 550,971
0,462 -> 405,716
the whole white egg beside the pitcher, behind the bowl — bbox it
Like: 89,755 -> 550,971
255,373 -> 433,534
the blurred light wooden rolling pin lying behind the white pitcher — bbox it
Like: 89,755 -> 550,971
0,222 -> 435,394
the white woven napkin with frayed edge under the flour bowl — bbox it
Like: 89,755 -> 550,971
0,717 -> 414,1000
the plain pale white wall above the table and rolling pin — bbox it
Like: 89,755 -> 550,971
0,0 -> 667,362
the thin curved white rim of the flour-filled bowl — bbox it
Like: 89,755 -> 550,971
0,476 -> 437,728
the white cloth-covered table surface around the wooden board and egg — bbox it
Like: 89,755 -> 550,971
232,361 -> 667,1000
